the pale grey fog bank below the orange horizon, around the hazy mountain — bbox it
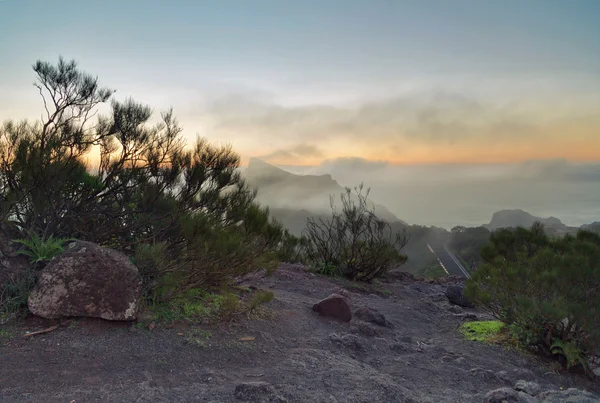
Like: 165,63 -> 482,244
244,158 -> 600,229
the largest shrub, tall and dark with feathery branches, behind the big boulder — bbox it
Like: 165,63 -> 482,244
0,58 -> 288,300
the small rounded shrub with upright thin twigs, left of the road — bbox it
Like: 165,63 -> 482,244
304,185 -> 408,281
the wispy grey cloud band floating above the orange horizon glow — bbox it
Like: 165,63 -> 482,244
209,92 -> 544,143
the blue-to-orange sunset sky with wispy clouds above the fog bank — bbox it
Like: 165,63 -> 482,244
0,0 -> 600,170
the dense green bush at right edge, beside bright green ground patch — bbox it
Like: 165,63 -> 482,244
465,223 -> 600,372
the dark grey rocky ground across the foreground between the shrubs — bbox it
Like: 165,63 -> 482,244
0,265 -> 600,403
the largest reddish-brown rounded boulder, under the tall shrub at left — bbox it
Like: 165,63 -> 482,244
28,241 -> 142,320
